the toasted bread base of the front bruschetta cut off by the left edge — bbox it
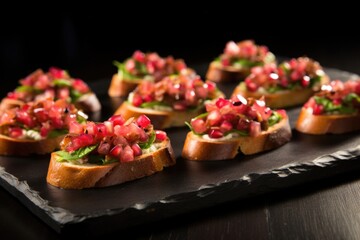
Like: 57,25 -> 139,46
0,134 -> 65,156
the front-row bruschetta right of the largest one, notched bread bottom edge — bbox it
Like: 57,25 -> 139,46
182,95 -> 292,161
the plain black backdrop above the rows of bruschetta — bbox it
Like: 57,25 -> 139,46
0,6 -> 360,95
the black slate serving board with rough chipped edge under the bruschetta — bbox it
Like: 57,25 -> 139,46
0,66 -> 360,234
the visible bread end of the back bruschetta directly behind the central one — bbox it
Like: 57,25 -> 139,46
108,73 -> 142,97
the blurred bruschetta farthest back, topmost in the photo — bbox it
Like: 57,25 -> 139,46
206,40 -> 276,82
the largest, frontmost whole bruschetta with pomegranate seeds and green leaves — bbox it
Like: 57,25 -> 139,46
46,115 -> 176,189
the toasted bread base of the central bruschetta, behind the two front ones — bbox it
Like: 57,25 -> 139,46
114,102 -> 204,129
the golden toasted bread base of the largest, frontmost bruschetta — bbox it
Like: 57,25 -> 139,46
46,139 -> 176,189
